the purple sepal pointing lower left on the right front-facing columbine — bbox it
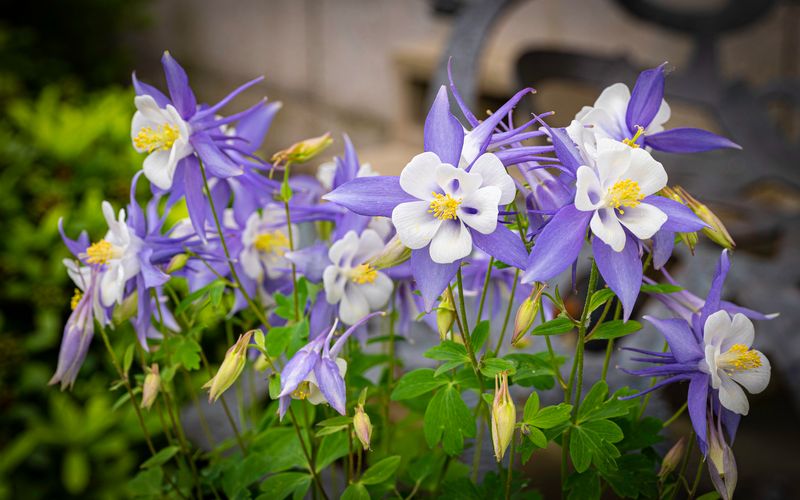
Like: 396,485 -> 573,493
522,205 -> 592,283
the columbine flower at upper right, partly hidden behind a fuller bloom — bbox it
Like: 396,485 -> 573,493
567,63 -> 741,153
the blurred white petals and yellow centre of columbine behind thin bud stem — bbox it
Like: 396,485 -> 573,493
240,205 -> 298,281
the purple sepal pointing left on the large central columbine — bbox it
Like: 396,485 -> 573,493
322,176 -> 418,217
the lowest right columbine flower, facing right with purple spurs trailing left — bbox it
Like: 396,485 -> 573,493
623,251 -> 770,453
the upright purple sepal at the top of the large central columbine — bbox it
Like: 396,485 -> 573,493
425,85 -> 464,166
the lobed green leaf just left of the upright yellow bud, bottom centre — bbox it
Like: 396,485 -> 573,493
423,386 -> 476,456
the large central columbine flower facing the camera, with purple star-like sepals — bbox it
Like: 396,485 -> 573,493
323,86 -> 532,311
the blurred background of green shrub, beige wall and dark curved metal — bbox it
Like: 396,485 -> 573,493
0,0 -> 800,498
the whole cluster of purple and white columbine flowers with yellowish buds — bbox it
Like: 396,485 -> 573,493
51,53 -> 770,497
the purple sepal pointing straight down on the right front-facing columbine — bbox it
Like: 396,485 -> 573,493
592,235 -> 642,321
